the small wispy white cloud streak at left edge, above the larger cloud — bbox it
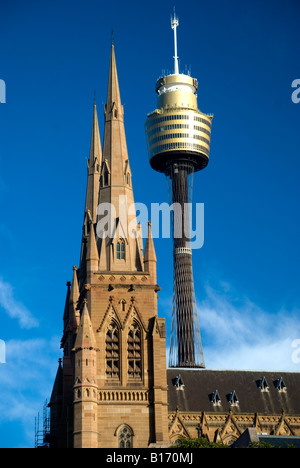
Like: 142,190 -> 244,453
0,278 -> 39,329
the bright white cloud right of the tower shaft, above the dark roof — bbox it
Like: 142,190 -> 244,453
198,285 -> 300,371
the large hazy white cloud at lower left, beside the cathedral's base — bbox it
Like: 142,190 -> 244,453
0,337 -> 61,448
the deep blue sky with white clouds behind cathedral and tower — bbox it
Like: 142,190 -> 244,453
0,0 -> 300,447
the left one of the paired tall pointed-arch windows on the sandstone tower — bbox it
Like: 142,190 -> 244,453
105,322 -> 120,380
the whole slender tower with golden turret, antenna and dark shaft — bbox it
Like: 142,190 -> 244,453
145,12 -> 212,368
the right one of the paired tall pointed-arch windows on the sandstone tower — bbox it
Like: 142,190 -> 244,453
127,322 -> 142,380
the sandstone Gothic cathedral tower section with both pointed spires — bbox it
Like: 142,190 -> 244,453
50,44 -> 168,448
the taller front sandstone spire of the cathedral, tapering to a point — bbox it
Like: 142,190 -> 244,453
97,44 -> 143,272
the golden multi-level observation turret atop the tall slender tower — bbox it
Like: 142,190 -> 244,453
145,74 -> 213,172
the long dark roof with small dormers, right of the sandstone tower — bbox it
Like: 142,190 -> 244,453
167,368 -> 300,414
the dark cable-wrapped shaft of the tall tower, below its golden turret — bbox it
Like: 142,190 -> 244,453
168,161 -> 204,367
